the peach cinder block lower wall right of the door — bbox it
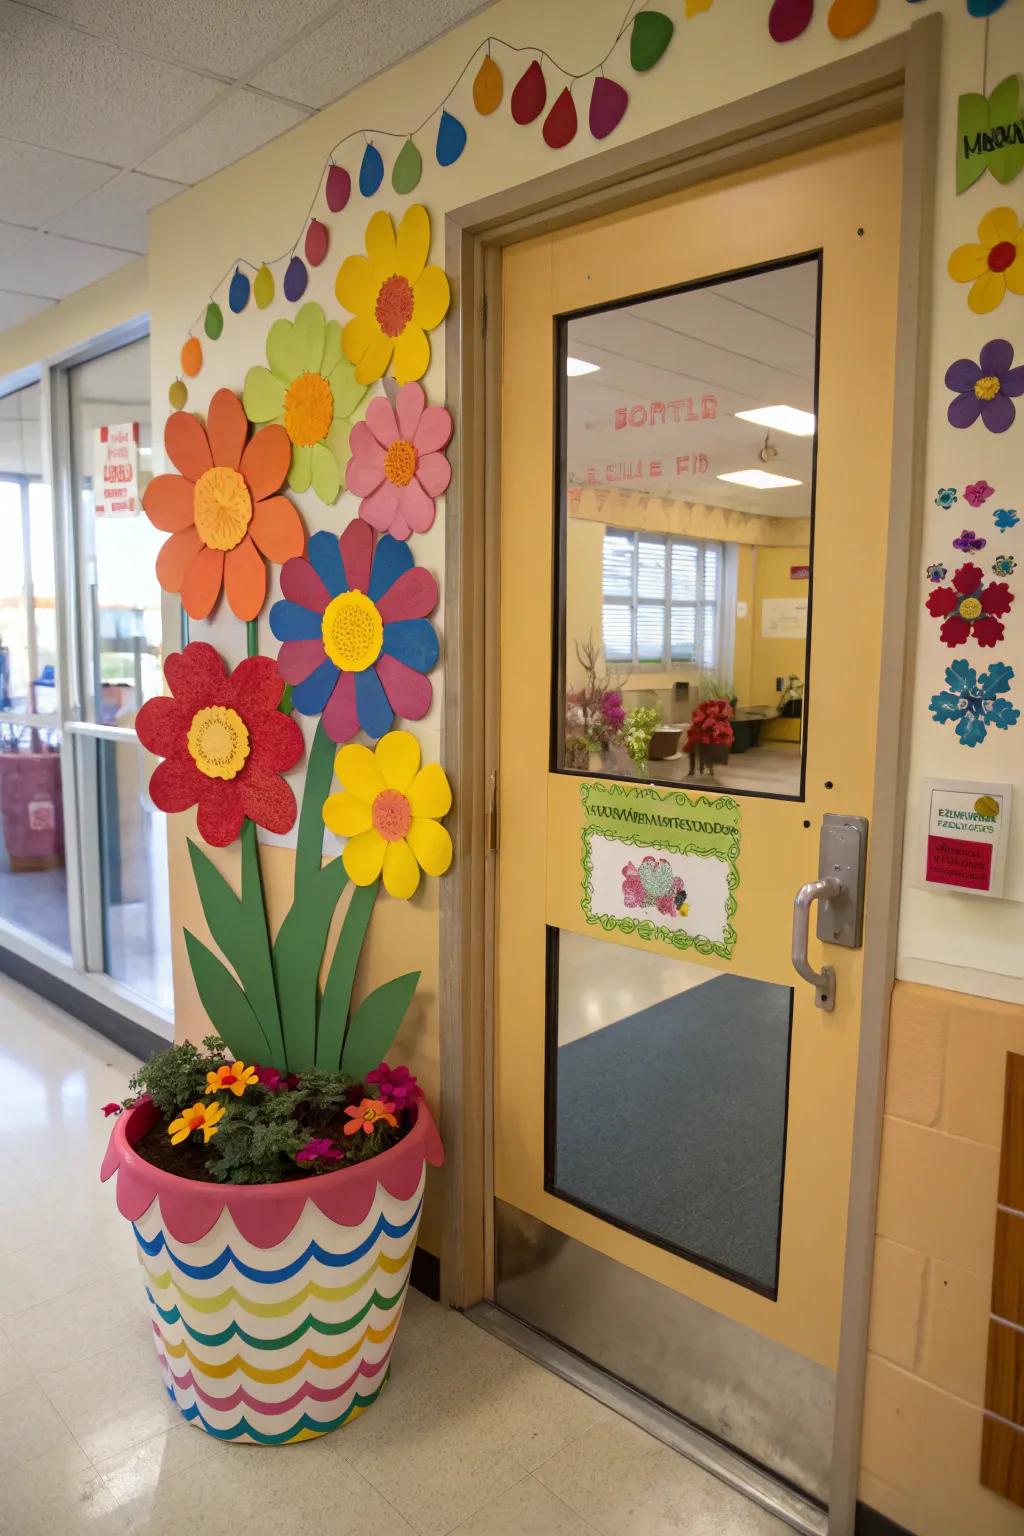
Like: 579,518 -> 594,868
861,982 -> 1024,1536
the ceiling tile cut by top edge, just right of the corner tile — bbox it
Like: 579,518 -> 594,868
24,0 -> 340,80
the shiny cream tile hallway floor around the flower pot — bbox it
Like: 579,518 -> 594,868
0,977 -> 788,1536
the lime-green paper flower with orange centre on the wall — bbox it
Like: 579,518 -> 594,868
243,304 -> 365,507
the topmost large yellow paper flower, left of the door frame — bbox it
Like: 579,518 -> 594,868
335,203 -> 451,384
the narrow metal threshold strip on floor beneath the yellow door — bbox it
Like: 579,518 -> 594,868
465,1301 -> 829,1536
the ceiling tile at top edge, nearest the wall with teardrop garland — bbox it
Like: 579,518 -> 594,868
252,0 -> 484,108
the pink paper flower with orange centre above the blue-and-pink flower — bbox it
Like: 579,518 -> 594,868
345,384 -> 451,539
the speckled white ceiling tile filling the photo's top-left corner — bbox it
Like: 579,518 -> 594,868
0,0 -> 224,168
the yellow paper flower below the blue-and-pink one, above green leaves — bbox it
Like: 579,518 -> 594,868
324,731 -> 451,900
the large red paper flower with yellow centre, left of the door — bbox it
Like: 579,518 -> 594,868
135,641 -> 302,848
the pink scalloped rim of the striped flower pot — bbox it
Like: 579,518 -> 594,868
100,1098 -> 444,1249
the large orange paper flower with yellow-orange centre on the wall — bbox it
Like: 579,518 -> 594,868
143,389 -> 306,619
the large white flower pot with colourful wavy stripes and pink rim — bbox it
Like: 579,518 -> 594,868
100,1100 -> 444,1445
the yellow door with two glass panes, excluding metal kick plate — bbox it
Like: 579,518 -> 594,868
494,124 -> 900,1492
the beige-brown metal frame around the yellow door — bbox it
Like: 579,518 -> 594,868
439,14 -> 943,1536
